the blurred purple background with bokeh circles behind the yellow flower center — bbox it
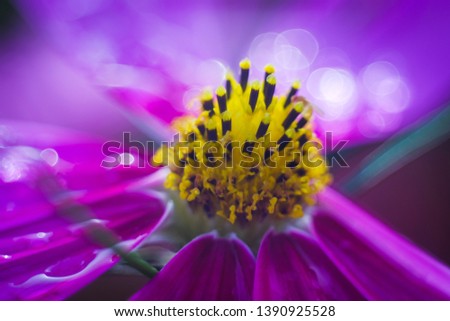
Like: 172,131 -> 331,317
0,0 -> 450,298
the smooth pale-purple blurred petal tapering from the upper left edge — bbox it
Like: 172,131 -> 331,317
0,35 -> 133,141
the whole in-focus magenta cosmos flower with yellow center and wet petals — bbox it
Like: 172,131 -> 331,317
1,57 -> 450,300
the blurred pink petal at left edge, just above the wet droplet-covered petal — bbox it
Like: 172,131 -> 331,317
0,121 -> 156,194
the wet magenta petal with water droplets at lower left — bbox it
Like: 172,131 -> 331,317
0,192 -> 164,300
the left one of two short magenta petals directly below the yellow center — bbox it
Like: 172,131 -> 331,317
132,234 -> 255,300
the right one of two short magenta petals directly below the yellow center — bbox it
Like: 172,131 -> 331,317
253,230 -> 363,300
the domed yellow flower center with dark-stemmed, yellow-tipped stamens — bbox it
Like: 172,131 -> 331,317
153,59 -> 331,224
